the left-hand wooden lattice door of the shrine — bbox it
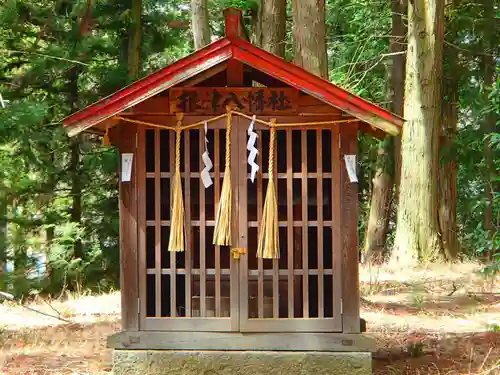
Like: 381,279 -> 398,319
138,121 -> 239,332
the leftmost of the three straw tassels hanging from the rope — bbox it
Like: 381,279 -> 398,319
168,125 -> 184,251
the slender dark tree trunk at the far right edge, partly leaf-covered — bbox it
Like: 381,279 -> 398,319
481,0 -> 498,239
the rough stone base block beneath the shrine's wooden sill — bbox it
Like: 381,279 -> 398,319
113,350 -> 372,375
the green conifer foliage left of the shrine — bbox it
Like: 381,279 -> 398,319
0,0 -> 189,296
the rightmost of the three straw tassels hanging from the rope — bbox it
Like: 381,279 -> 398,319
257,125 -> 280,259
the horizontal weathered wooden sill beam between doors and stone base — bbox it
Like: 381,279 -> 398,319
107,332 -> 376,352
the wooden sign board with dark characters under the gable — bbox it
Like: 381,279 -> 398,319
169,87 -> 299,115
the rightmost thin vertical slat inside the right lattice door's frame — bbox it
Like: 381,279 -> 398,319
316,129 -> 325,318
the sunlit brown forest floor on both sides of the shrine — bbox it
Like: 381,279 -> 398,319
0,264 -> 500,375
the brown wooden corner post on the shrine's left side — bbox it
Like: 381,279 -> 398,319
117,125 -> 140,331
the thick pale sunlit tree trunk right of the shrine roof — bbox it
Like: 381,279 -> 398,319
391,0 -> 444,266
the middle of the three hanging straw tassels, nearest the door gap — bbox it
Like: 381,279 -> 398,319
213,107 -> 233,246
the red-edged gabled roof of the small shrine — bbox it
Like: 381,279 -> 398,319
63,9 -> 404,136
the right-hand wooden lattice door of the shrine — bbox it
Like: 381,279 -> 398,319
238,122 -> 342,332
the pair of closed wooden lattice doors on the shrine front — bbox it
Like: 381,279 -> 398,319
137,118 -> 342,332
